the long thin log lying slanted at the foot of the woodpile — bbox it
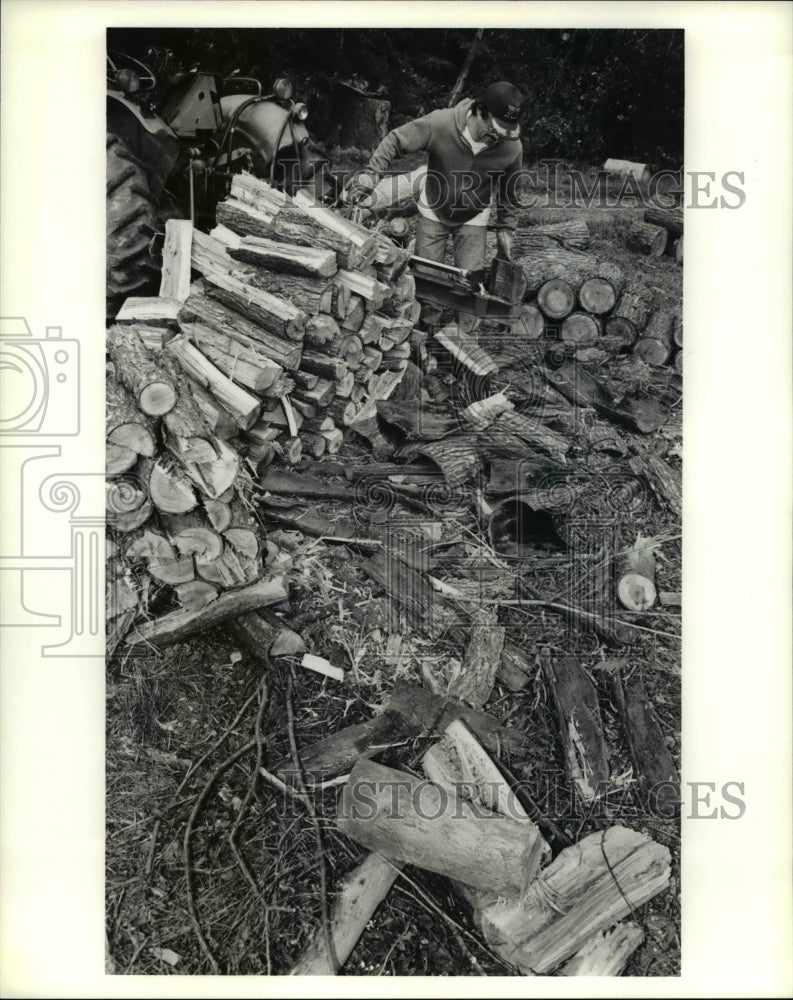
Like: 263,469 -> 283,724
126,577 -> 289,646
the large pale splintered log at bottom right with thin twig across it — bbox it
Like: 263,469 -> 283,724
476,826 -> 670,975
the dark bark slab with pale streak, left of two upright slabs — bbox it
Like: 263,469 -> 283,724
543,656 -> 611,803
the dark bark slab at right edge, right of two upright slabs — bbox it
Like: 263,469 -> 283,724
612,671 -> 680,819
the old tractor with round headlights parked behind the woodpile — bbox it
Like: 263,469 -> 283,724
106,49 -> 338,319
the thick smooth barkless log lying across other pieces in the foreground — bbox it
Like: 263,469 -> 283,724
337,759 -> 542,898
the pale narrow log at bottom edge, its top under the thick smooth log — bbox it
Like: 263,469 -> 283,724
289,854 -> 402,976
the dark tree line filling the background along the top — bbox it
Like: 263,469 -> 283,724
108,28 -> 684,167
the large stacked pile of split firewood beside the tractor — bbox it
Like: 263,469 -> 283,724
106,174 -> 420,640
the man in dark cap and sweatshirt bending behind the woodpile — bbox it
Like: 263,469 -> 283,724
348,80 -> 526,271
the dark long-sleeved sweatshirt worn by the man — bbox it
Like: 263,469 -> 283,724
369,98 -> 523,229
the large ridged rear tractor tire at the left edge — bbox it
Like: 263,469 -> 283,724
106,132 -> 158,320
